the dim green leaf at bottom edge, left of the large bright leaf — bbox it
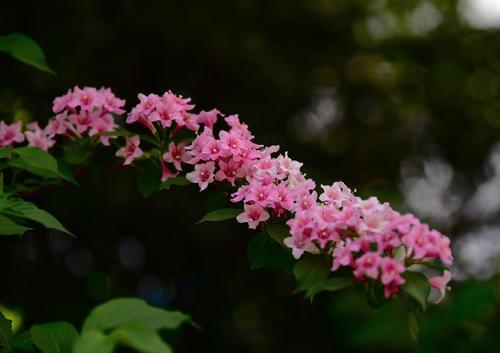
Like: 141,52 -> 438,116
30,321 -> 78,353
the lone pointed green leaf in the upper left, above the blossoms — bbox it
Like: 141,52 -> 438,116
0,33 -> 55,75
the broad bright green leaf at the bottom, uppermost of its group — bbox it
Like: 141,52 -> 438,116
82,298 -> 191,333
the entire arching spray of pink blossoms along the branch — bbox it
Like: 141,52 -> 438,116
0,87 -> 453,297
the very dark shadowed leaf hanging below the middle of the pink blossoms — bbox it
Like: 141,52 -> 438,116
247,233 -> 294,271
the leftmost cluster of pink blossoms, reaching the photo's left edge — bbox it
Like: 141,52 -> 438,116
0,87 -> 125,151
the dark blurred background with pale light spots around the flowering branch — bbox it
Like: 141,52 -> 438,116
0,0 -> 500,353
